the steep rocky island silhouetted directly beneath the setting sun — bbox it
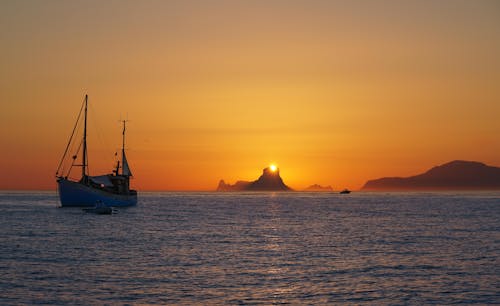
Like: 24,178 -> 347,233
217,167 -> 292,191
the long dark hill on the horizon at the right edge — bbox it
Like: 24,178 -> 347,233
362,160 -> 500,190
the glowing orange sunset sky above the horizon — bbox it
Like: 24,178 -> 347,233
0,0 -> 500,190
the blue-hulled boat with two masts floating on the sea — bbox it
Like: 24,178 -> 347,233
56,95 -> 137,207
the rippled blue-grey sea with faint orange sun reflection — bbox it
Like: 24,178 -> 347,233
0,191 -> 500,305
